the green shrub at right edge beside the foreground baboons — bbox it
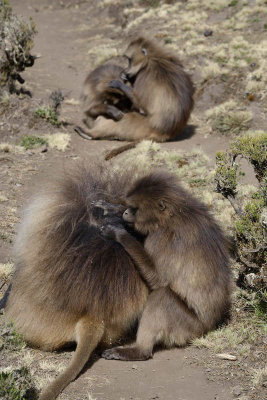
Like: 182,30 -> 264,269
215,132 -> 267,294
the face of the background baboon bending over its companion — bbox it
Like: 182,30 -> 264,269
122,43 -> 148,83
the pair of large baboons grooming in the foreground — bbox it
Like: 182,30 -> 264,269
6,166 -> 229,400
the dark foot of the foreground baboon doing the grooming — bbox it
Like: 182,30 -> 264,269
102,346 -> 152,361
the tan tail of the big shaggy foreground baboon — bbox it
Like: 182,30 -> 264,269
39,319 -> 104,400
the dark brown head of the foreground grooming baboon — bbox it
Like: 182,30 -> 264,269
123,172 -> 180,235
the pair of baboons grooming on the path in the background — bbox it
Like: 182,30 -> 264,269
77,38 -> 194,150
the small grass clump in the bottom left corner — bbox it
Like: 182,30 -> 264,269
0,367 -> 38,400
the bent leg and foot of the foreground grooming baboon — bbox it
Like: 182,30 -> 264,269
102,288 -> 203,361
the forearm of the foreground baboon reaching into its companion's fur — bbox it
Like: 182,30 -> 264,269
116,231 -> 163,290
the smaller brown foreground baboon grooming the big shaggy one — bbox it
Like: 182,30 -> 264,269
103,172 -> 230,360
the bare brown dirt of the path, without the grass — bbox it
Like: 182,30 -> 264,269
0,0 -> 266,400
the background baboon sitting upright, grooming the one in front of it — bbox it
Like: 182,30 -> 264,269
81,37 -> 194,142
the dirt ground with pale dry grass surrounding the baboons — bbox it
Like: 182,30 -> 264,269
0,0 -> 266,400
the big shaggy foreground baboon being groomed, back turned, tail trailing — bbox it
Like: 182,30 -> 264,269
6,167 -> 148,400
